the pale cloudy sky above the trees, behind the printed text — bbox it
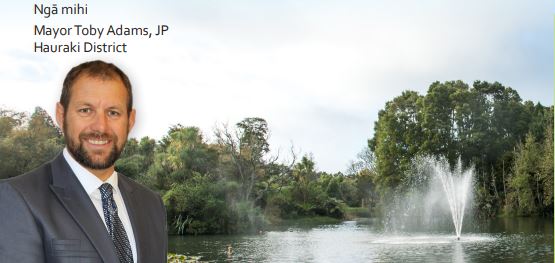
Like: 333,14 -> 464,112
0,0 -> 555,172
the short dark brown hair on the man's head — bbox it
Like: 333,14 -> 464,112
60,60 -> 133,115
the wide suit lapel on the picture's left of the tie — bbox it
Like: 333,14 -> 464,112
50,154 -> 117,262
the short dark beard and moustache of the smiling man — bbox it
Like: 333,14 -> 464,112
64,122 -> 123,170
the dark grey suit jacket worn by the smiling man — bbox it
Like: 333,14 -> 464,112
0,154 -> 168,263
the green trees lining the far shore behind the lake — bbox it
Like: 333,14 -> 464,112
0,81 -> 553,234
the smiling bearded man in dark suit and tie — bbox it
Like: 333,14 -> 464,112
0,61 -> 167,263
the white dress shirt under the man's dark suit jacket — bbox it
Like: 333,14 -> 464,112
63,150 -> 137,262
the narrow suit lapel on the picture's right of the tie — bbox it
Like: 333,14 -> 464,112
118,174 -> 143,262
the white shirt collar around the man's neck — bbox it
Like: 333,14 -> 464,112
63,147 -> 119,195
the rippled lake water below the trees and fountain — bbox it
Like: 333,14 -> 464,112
169,218 -> 553,263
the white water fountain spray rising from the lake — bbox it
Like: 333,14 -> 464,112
384,156 -> 474,240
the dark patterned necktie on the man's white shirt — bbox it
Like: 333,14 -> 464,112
99,183 -> 133,263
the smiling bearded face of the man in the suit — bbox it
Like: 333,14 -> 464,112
56,75 -> 135,170
